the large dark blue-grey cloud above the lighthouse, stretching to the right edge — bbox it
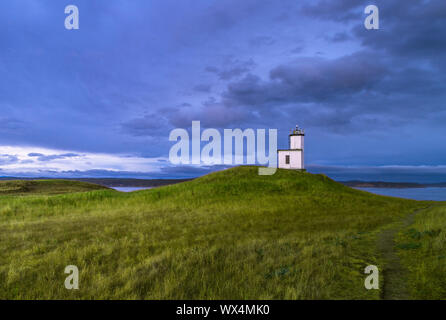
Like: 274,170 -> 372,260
219,52 -> 446,131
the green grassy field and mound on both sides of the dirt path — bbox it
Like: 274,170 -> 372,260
0,166 -> 446,299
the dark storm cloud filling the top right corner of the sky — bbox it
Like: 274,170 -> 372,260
302,0 -> 446,62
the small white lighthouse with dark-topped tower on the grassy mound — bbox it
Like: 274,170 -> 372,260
277,126 -> 305,170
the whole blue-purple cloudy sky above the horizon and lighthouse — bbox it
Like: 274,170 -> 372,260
0,0 -> 446,181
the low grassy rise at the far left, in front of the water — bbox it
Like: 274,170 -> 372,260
0,180 -> 110,196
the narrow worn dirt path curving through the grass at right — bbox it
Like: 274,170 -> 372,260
378,208 -> 427,300
